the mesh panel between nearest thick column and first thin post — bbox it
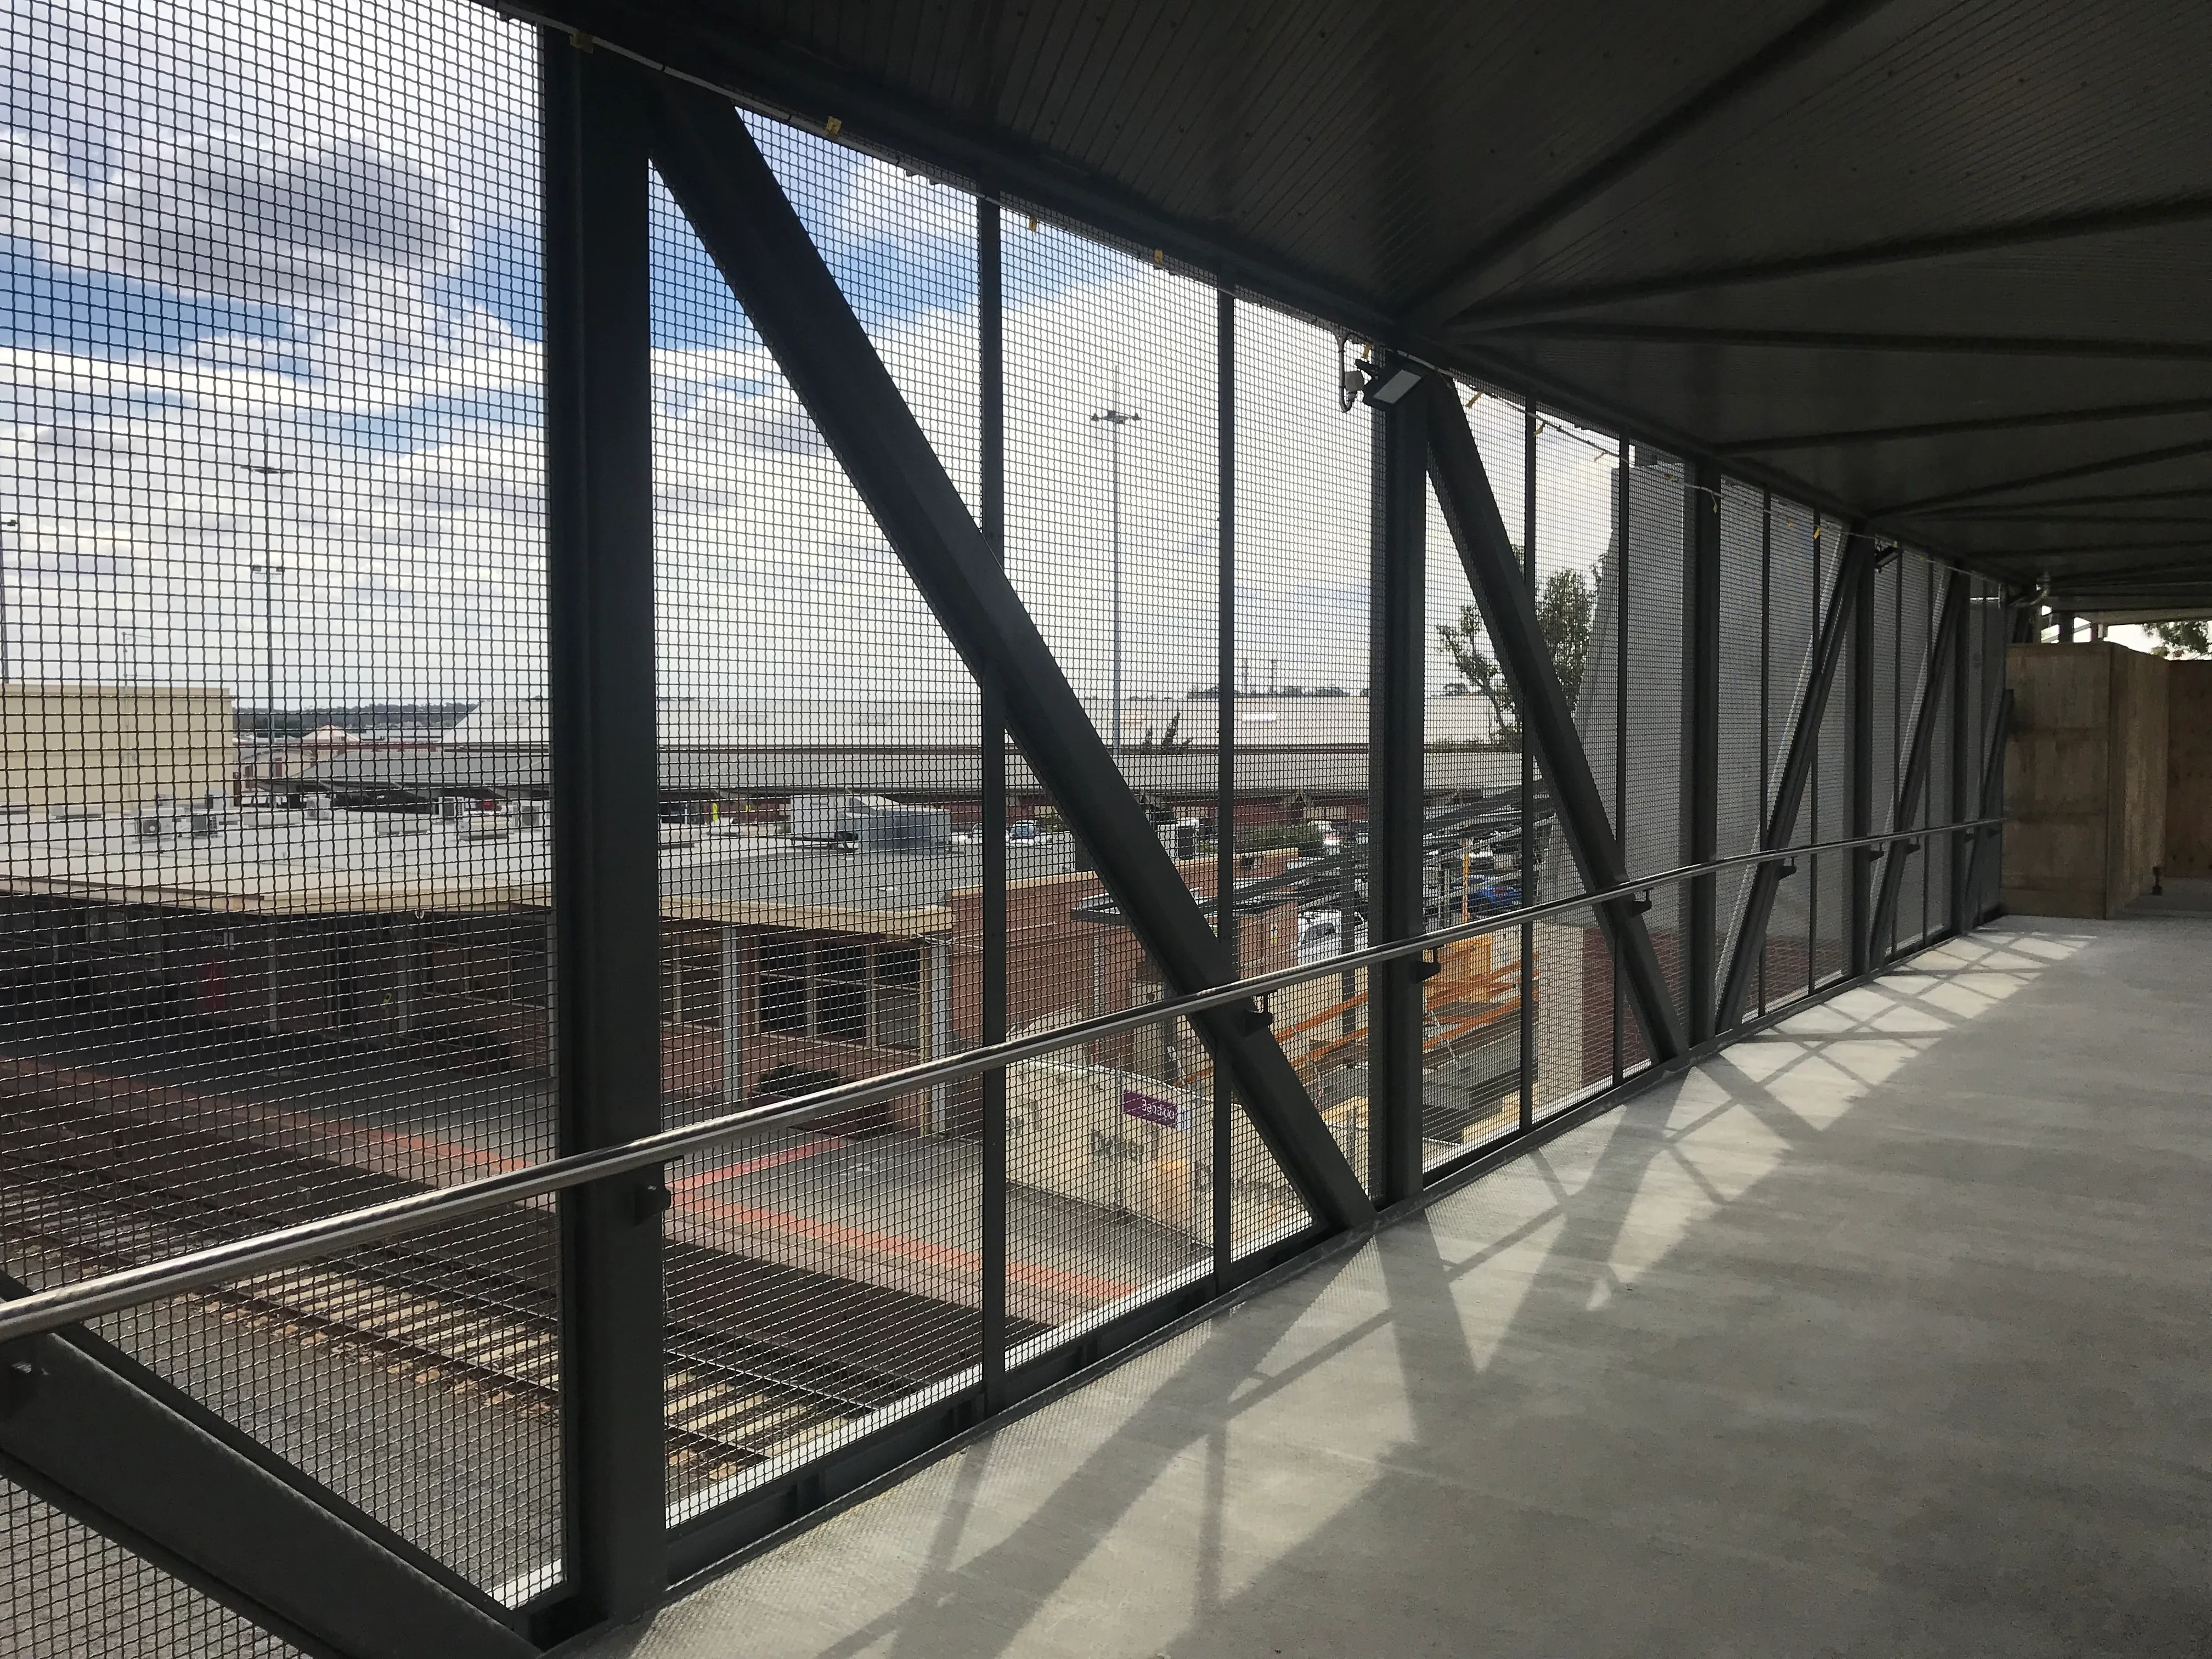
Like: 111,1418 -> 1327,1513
652,122 -> 982,1517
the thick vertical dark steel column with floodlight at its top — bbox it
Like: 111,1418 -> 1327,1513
1367,354 -> 1424,1203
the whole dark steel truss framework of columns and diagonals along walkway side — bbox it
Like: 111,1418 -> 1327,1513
0,39 -> 2004,1659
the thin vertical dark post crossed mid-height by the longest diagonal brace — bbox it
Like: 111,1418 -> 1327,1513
975,201 -> 1009,1411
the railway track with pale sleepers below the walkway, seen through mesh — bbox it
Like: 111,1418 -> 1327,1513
0,1095 -> 1026,1489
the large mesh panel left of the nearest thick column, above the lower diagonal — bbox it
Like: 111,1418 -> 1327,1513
0,0 -> 560,1617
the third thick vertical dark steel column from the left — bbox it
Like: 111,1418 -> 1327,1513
1681,460 -> 1721,1044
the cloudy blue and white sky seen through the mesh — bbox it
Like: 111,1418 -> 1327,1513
0,0 -> 1612,734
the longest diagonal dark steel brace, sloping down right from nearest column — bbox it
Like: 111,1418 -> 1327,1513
648,77 -> 1374,1230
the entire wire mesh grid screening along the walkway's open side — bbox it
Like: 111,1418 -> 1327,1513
0,19 -> 2004,1655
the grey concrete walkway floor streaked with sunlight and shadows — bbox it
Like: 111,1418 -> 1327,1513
593,916 -> 2212,1659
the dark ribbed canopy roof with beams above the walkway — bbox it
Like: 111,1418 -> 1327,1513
546,0 -> 2212,613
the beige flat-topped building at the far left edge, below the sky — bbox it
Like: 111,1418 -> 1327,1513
0,686 -> 236,812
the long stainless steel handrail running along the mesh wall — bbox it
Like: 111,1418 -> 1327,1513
0,816 -> 2004,1342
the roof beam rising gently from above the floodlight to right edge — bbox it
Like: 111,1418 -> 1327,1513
1449,197 -> 2212,328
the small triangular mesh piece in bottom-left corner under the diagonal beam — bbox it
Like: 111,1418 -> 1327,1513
0,1477 -> 298,1659
